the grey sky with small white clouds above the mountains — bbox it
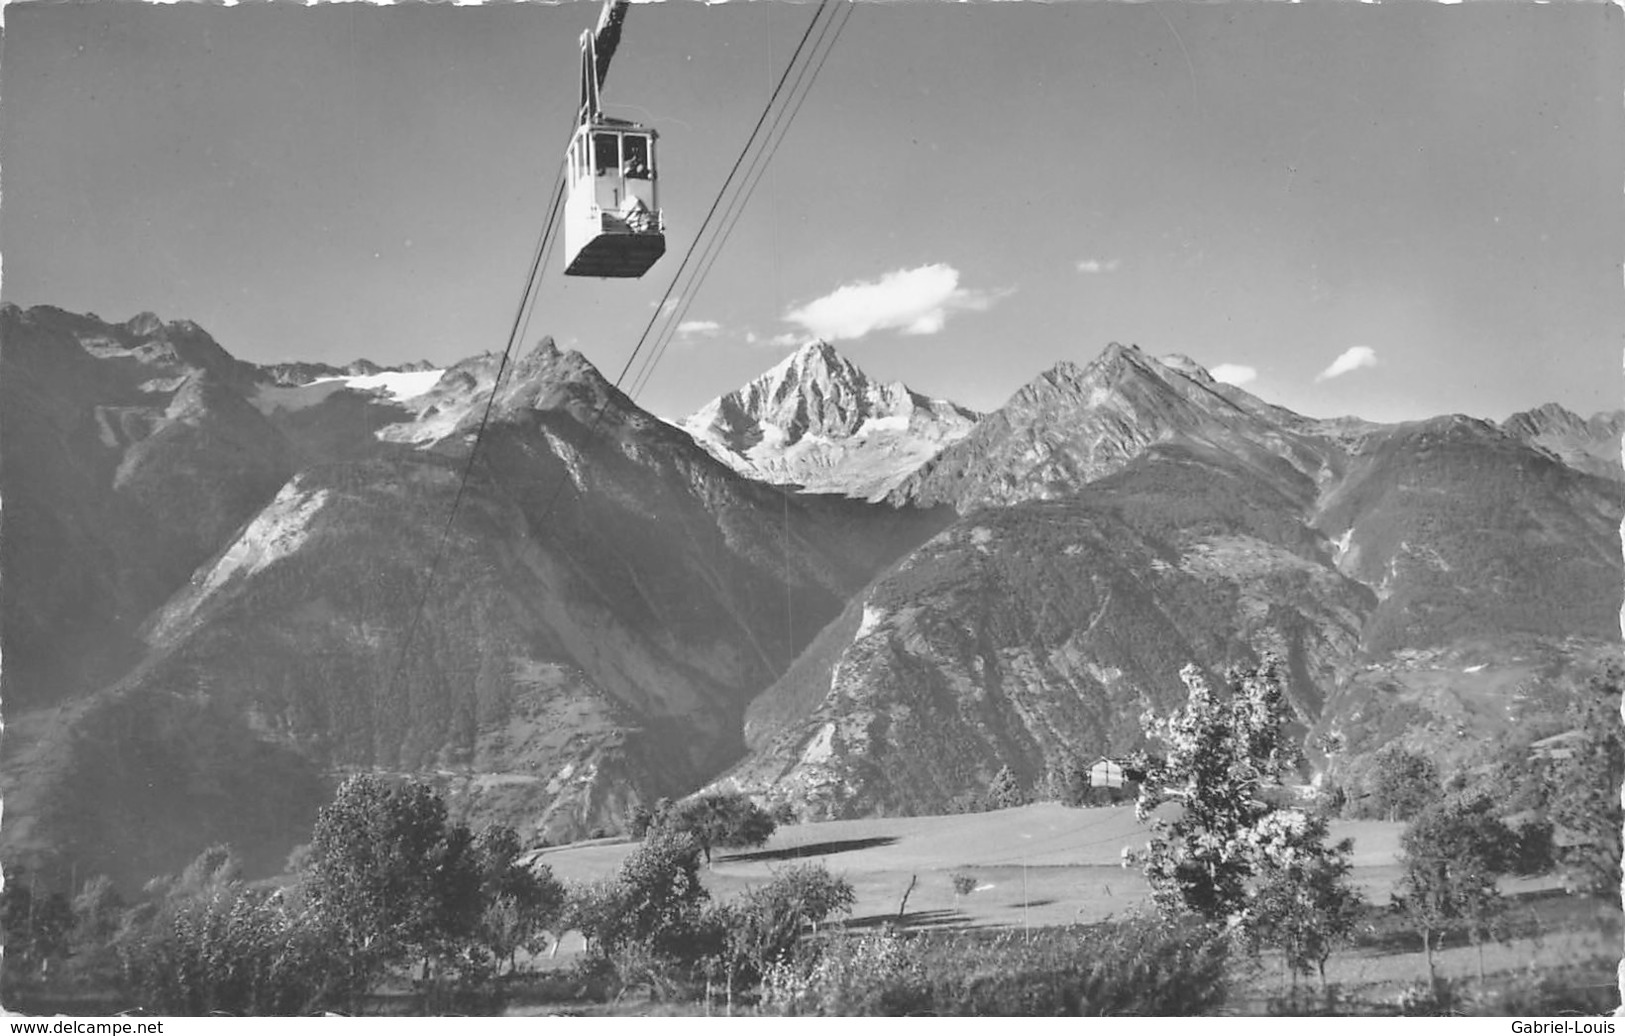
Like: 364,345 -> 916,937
0,0 -> 1625,421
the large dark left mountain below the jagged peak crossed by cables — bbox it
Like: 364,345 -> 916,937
3,310 -> 943,882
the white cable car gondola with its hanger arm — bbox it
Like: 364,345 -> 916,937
564,0 -> 666,278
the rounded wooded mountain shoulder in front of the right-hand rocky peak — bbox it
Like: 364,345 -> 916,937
728,445 -> 1376,817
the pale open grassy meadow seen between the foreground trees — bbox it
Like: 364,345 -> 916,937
538,802 -> 1620,1013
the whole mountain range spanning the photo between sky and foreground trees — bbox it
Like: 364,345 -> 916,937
0,305 -> 1625,885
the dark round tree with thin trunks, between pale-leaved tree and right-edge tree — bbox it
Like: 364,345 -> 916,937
1394,799 -> 1518,981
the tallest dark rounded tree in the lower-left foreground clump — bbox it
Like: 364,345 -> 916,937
304,775 -> 481,997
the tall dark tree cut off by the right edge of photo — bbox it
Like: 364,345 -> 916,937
1547,666 -> 1625,898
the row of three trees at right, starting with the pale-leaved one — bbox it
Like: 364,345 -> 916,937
1125,659 -> 1625,986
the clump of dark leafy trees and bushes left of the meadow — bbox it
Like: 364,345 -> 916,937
101,776 -> 566,1015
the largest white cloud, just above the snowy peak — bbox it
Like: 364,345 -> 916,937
785,263 -> 1009,341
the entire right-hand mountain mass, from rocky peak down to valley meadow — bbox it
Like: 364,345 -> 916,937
722,346 -> 1625,817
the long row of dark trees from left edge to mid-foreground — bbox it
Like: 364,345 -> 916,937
0,776 -> 853,1015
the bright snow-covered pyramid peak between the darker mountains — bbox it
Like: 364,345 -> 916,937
678,341 -> 978,499
